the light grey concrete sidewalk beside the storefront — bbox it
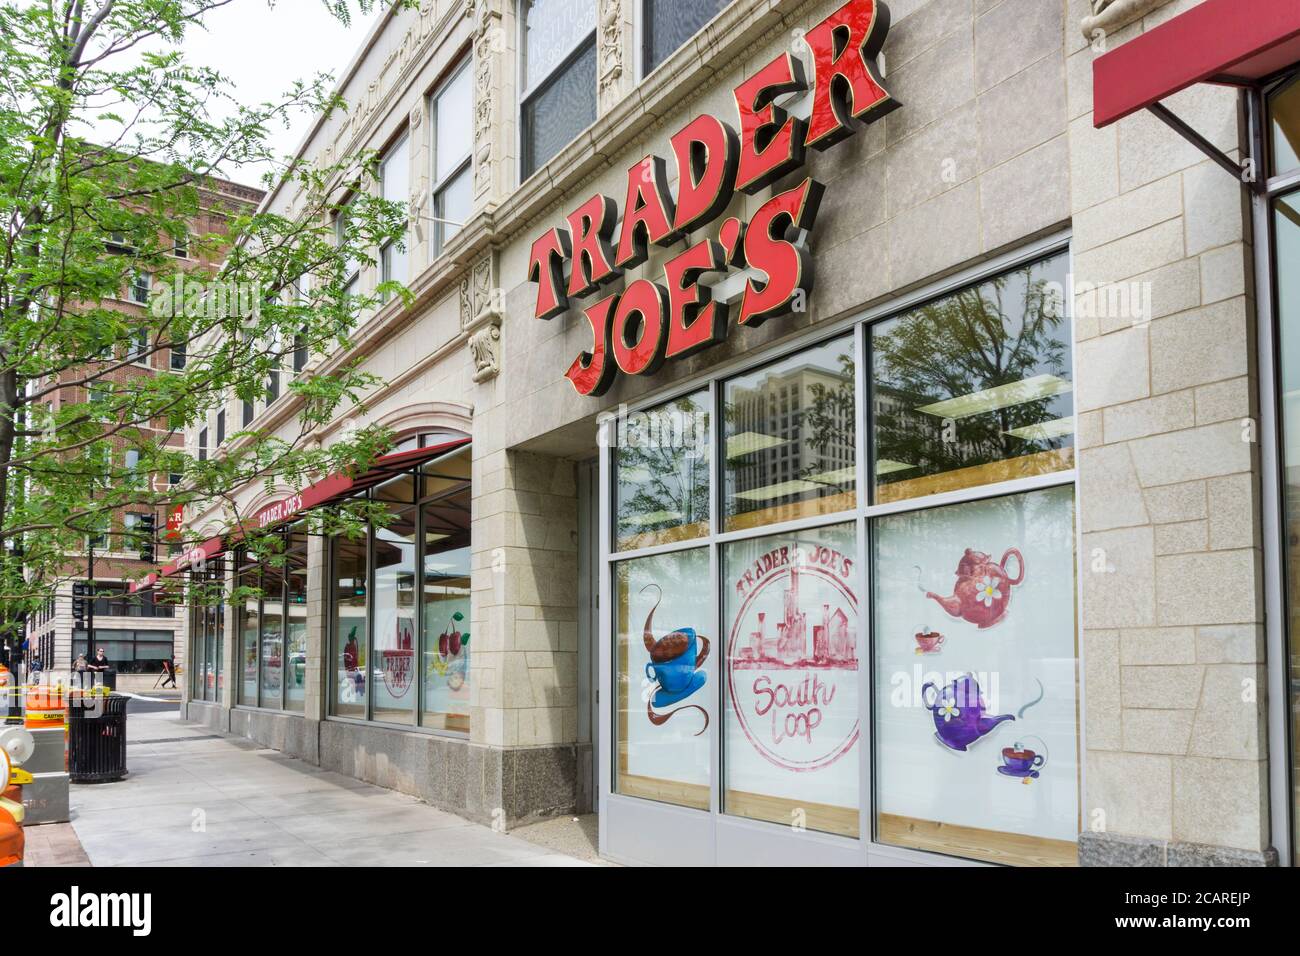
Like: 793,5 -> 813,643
72,710 -> 585,866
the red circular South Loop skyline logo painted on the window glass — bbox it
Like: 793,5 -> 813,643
727,545 -> 858,771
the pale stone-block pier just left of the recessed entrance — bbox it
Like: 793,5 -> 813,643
471,450 -> 577,825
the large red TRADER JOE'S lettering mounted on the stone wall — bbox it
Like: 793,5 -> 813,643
528,0 -> 898,395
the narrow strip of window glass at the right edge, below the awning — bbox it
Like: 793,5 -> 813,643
1273,193 -> 1300,853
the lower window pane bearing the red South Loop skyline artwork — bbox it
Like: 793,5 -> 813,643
723,524 -> 861,836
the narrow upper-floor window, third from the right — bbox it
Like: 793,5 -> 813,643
430,61 -> 473,255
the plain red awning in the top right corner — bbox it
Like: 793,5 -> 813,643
1092,0 -> 1300,129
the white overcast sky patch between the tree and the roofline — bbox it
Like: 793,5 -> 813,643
148,0 -> 382,186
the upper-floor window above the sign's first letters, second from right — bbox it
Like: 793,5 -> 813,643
520,0 -> 595,179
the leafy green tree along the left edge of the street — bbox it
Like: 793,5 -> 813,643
0,0 -> 413,642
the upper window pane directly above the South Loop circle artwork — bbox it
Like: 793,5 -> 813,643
724,336 -> 857,531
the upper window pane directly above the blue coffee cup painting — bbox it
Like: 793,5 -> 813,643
608,390 -> 710,550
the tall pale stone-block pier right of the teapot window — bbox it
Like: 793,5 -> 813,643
1066,4 -> 1286,865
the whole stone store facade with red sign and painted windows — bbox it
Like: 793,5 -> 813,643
173,0 -> 1291,865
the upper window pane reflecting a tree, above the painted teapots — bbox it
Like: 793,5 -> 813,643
871,254 -> 1074,503
